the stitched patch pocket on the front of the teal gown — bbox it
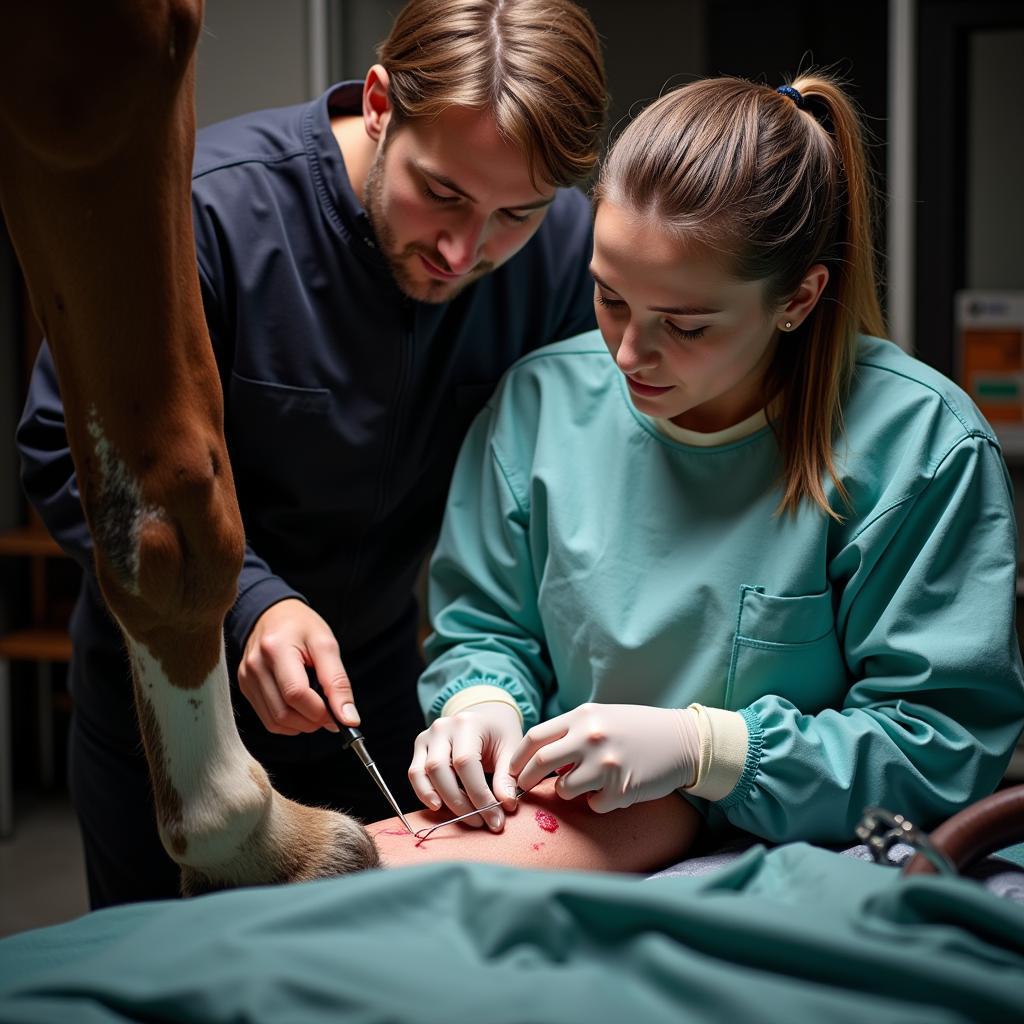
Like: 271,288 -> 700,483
725,587 -> 849,715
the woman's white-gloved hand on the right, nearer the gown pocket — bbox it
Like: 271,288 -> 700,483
509,703 -> 700,814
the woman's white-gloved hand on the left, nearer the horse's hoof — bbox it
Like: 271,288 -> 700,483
409,700 -> 522,831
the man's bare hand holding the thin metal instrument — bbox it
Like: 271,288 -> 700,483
239,598 -> 359,736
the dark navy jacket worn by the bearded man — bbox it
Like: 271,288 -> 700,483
18,82 -> 594,761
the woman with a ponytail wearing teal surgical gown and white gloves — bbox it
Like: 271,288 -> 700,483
410,76 -> 1024,843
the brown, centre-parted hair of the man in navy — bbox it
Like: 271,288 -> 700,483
378,0 -> 607,185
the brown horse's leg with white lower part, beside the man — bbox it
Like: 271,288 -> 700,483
0,0 -> 377,892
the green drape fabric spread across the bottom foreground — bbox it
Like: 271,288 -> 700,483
0,844 -> 1024,1024
